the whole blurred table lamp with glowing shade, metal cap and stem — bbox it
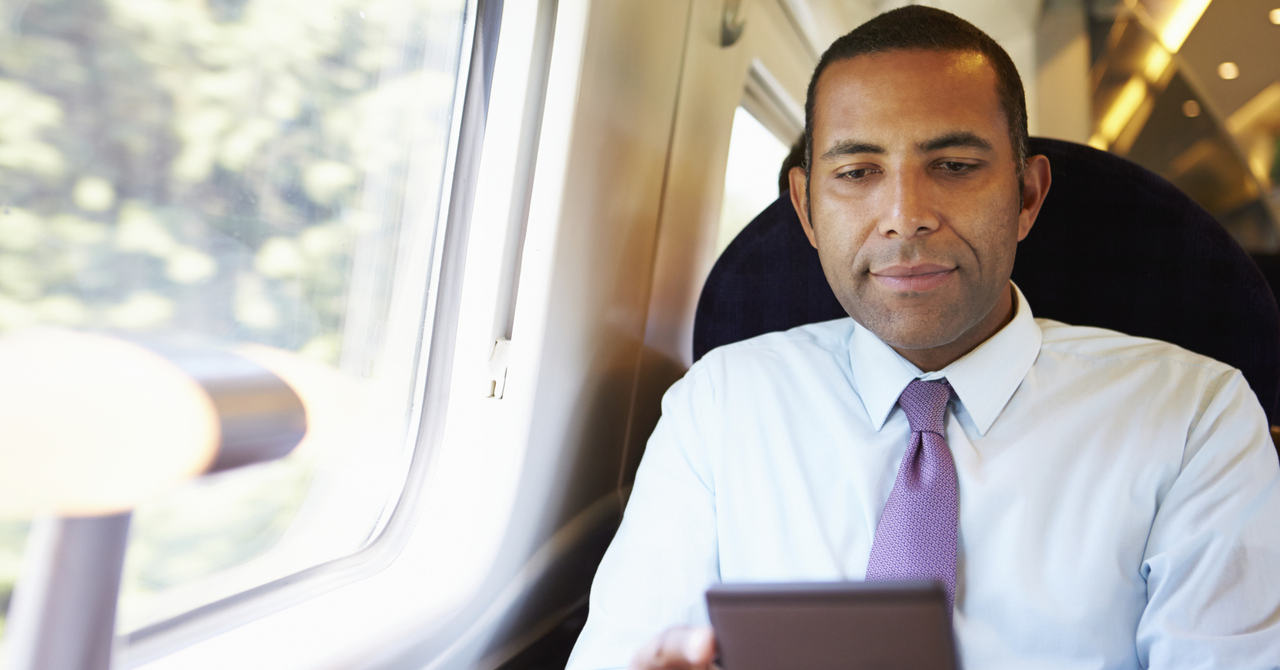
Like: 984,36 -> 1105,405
0,328 -> 307,670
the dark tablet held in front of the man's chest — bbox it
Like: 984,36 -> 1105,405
707,582 -> 957,670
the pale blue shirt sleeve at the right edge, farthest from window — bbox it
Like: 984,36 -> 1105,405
1137,370 -> 1280,670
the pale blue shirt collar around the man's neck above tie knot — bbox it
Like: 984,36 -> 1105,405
849,286 -> 1041,434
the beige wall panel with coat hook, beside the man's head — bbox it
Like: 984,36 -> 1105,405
621,0 -> 814,486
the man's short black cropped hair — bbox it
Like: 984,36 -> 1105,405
804,5 -> 1028,178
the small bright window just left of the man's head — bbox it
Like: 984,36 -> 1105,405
716,106 -> 790,256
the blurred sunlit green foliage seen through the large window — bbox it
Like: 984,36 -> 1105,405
0,0 -> 462,650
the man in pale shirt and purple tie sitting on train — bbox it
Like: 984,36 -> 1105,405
570,6 -> 1280,670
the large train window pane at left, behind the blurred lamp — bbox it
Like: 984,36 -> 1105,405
0,0 -> 467,650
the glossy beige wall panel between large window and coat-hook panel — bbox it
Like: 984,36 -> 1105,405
513,0 -> 690,537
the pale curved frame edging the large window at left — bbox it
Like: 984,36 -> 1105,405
114,0 -> 503,669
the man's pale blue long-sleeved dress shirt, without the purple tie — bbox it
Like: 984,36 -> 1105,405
568,291 -> 1280,670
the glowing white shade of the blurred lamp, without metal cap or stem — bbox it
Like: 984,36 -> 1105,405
0,328 -> 221,518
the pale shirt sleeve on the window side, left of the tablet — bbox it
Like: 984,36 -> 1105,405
567,365 -> 719,670
